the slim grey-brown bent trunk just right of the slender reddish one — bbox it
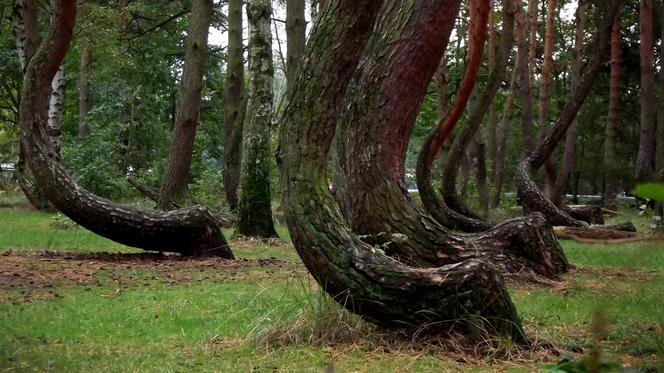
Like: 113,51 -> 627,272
442,1 -> 516,225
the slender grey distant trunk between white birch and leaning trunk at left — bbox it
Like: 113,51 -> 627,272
78,3 -> 92,137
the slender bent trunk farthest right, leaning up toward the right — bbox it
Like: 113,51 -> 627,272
514,0 -> 620,227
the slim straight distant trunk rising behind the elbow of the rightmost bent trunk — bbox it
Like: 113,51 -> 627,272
515,0 -> 535,157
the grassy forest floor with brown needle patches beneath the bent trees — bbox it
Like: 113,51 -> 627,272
0,193 -> 664,372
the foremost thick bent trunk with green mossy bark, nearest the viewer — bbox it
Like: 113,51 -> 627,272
278,0 -> 526,342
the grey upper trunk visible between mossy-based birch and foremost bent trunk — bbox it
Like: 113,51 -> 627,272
286,0 -> 307,88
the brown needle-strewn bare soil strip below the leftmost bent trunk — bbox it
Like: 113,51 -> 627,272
0,251 -> 294,303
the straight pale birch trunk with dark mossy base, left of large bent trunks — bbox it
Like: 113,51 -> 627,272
236,0 -> 277,238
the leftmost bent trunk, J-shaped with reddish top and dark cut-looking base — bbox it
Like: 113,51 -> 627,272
20,0 -> 233,258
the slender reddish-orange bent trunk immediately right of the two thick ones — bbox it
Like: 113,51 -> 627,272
417,2 -> 496,232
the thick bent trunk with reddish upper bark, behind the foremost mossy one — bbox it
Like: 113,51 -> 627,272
335,0 -> 567,277
